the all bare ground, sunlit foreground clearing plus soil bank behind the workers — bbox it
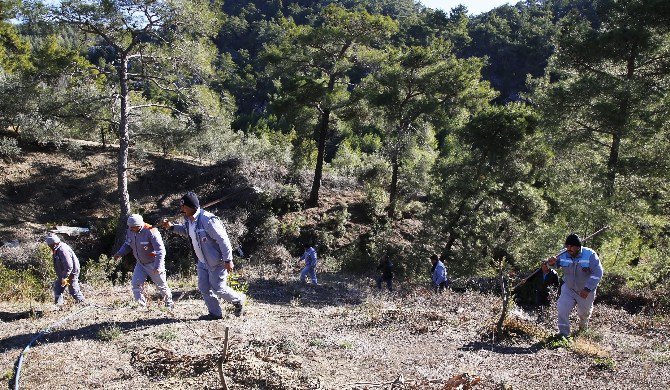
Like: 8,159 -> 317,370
0,144 -> 670,389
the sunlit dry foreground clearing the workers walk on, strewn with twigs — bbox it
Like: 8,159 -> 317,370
0,268 -> 670,389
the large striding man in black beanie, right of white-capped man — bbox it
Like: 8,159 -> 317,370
163,192 -> 246,320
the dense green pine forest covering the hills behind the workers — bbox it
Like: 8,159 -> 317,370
0,0 -> 670,299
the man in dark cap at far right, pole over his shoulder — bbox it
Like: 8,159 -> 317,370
546,233 -> 603,337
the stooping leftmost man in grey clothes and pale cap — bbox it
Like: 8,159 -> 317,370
45,234 -> 84,306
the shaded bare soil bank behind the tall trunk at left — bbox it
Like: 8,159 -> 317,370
0,141 -> 258,236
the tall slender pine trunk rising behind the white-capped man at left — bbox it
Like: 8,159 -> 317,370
114,58 -> 130,248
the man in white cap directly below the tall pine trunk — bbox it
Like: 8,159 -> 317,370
114,214 -> 174,309
